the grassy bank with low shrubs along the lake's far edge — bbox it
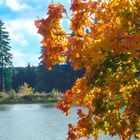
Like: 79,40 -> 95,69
0,90 -> 61,104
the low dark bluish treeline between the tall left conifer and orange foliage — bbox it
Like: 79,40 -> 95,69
12,64 -> 84,93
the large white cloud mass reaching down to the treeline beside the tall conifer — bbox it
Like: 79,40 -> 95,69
5,19 -> 40,66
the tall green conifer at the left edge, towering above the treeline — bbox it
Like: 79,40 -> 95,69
0,19 -> 12,92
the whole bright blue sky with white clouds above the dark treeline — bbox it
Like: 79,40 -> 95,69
0,0 -> 70,66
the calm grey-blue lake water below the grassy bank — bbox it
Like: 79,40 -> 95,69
0,104 -> 132,140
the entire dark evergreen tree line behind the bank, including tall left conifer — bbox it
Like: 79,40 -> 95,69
0,19 -> 84,92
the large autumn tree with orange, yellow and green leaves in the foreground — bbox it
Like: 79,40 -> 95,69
35,0 -> 140,140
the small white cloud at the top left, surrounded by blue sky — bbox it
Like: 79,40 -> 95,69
5,0 -> 31,11
